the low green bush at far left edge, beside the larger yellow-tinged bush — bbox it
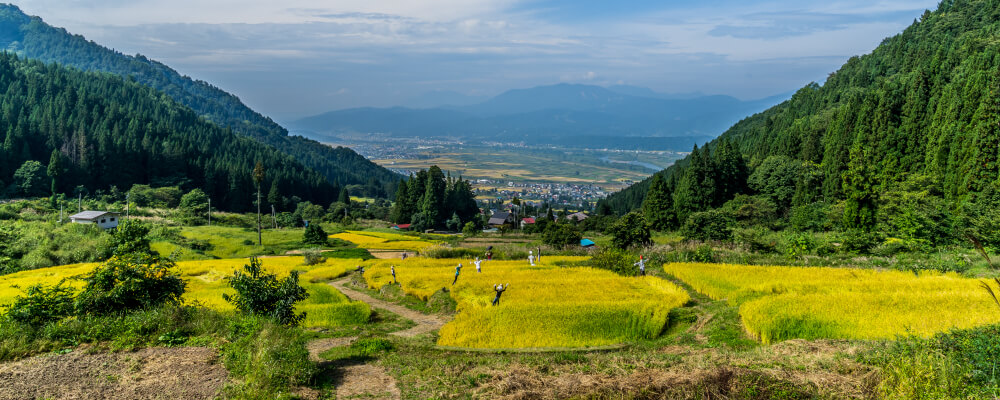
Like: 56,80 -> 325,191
4,282 -> 74,328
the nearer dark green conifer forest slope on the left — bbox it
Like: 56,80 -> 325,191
0,53 -> 340,211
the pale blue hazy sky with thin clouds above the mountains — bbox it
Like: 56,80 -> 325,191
16,0 -> 937,120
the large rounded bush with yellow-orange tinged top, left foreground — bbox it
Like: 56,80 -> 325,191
76,253 -> 187,315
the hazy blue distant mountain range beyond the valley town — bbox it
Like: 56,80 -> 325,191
289,84 -> 791,150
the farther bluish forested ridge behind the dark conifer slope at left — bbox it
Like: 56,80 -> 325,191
0,4 -> 399,197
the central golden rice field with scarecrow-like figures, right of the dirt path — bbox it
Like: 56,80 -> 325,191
365,257 -> 688,349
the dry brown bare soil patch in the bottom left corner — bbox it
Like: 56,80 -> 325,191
0,347 -> 229,400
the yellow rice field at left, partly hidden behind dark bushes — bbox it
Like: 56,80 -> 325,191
0,257 -> 371,327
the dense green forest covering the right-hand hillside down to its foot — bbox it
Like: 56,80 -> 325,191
599,0 -> 1000,246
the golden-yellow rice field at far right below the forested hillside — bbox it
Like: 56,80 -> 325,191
663,263 -> 1000,343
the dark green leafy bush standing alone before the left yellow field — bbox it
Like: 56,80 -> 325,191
222,257 -> 309,326
